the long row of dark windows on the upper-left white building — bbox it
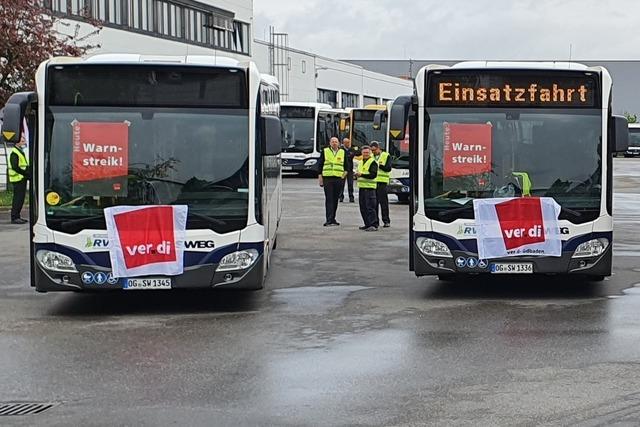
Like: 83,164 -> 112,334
47,0 -> 251,55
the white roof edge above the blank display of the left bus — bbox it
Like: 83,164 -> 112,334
49,53 -> 249,68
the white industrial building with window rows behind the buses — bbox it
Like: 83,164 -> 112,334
45,0 -> 413,108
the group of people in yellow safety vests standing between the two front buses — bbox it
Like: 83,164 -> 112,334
318,137 -> 391,231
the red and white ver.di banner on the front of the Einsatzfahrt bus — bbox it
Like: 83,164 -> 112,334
473,197 -> 562,259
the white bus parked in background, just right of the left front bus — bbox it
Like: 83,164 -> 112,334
280,102 -> 340,177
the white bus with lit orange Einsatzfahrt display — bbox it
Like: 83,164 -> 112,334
391,62 -> 628,280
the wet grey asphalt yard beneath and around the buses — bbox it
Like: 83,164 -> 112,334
0,159 -> 640,426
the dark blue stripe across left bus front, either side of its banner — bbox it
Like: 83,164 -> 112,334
34,242 -> 264,268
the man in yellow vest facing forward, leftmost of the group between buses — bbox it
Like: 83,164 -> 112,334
318,137 -> 348,227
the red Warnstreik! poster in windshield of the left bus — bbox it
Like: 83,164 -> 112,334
72,121 -> 129,196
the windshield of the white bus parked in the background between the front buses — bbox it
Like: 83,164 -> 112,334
280,106 -> 315,154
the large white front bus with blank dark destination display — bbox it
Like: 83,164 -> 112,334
3,55 -> 282,292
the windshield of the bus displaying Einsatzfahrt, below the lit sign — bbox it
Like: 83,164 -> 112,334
424,108 -> 602,223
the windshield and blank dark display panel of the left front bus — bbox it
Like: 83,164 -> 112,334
43,66 -> 249,233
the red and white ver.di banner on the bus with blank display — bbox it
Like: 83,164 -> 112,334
104,206 -> 188,277
